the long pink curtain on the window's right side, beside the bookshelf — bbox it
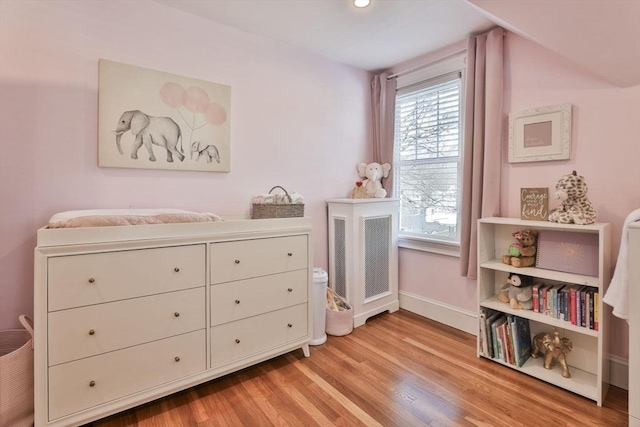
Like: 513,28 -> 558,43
460,27 -> 504,279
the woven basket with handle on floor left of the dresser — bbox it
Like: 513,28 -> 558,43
0,315 -> 33,427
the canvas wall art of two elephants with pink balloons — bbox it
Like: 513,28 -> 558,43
98,59 -> 231,172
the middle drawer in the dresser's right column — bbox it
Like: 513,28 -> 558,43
211,269 -> 309,326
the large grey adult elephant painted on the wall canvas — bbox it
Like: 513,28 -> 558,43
115,110 -> 184,163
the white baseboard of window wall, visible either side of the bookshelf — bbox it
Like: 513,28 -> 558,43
399,292 -> 629,390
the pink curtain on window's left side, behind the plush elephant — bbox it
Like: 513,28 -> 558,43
371,73 -> 396,197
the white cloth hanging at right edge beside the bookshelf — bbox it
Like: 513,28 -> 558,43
602,209 -> 640,322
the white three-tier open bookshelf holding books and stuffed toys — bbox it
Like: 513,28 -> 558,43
478,218 -> 610,406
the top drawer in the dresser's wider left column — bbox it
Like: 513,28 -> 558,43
47,245 -> 206,311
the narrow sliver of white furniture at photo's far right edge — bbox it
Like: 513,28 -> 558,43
629,222 -> 640,427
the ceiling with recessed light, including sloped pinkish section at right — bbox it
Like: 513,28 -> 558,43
155,0 -> 640,87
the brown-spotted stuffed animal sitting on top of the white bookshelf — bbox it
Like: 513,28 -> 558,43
549,171 -> 596,225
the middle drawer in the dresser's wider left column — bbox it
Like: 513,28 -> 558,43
48,287 -> 206,366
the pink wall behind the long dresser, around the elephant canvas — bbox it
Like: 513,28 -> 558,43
0,0 -> 371,329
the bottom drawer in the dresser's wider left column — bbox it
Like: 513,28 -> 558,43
49,330 -> 206,420
